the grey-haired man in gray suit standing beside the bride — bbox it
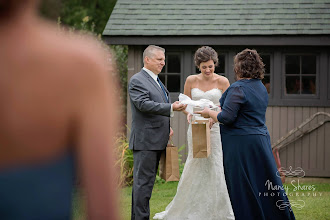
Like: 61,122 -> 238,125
128,45 -> 187,220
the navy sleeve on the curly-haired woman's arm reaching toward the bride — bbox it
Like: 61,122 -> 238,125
217,86 -> 246,125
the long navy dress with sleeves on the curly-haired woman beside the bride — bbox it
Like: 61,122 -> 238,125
218,79 -> 295,220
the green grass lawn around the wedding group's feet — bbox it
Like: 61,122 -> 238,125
121,182 -> 330,220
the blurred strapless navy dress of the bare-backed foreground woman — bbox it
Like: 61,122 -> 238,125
0,155 -> 74,220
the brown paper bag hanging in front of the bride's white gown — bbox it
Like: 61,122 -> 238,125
191,119 -> 211,158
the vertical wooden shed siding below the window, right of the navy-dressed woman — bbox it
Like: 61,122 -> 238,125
266,107 -> 330,177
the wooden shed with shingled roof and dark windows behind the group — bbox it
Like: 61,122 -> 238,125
103,0 -> 330,177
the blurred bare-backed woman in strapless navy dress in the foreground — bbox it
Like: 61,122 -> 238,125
0,0 -> 119,220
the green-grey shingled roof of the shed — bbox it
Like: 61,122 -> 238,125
103,0 -> 330,36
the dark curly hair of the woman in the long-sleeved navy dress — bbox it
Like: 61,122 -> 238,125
234,49 -> 265,79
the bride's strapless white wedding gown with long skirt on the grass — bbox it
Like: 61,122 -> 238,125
153,88 -> 235,220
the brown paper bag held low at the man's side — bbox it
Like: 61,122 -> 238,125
159,144 -> 180,181
